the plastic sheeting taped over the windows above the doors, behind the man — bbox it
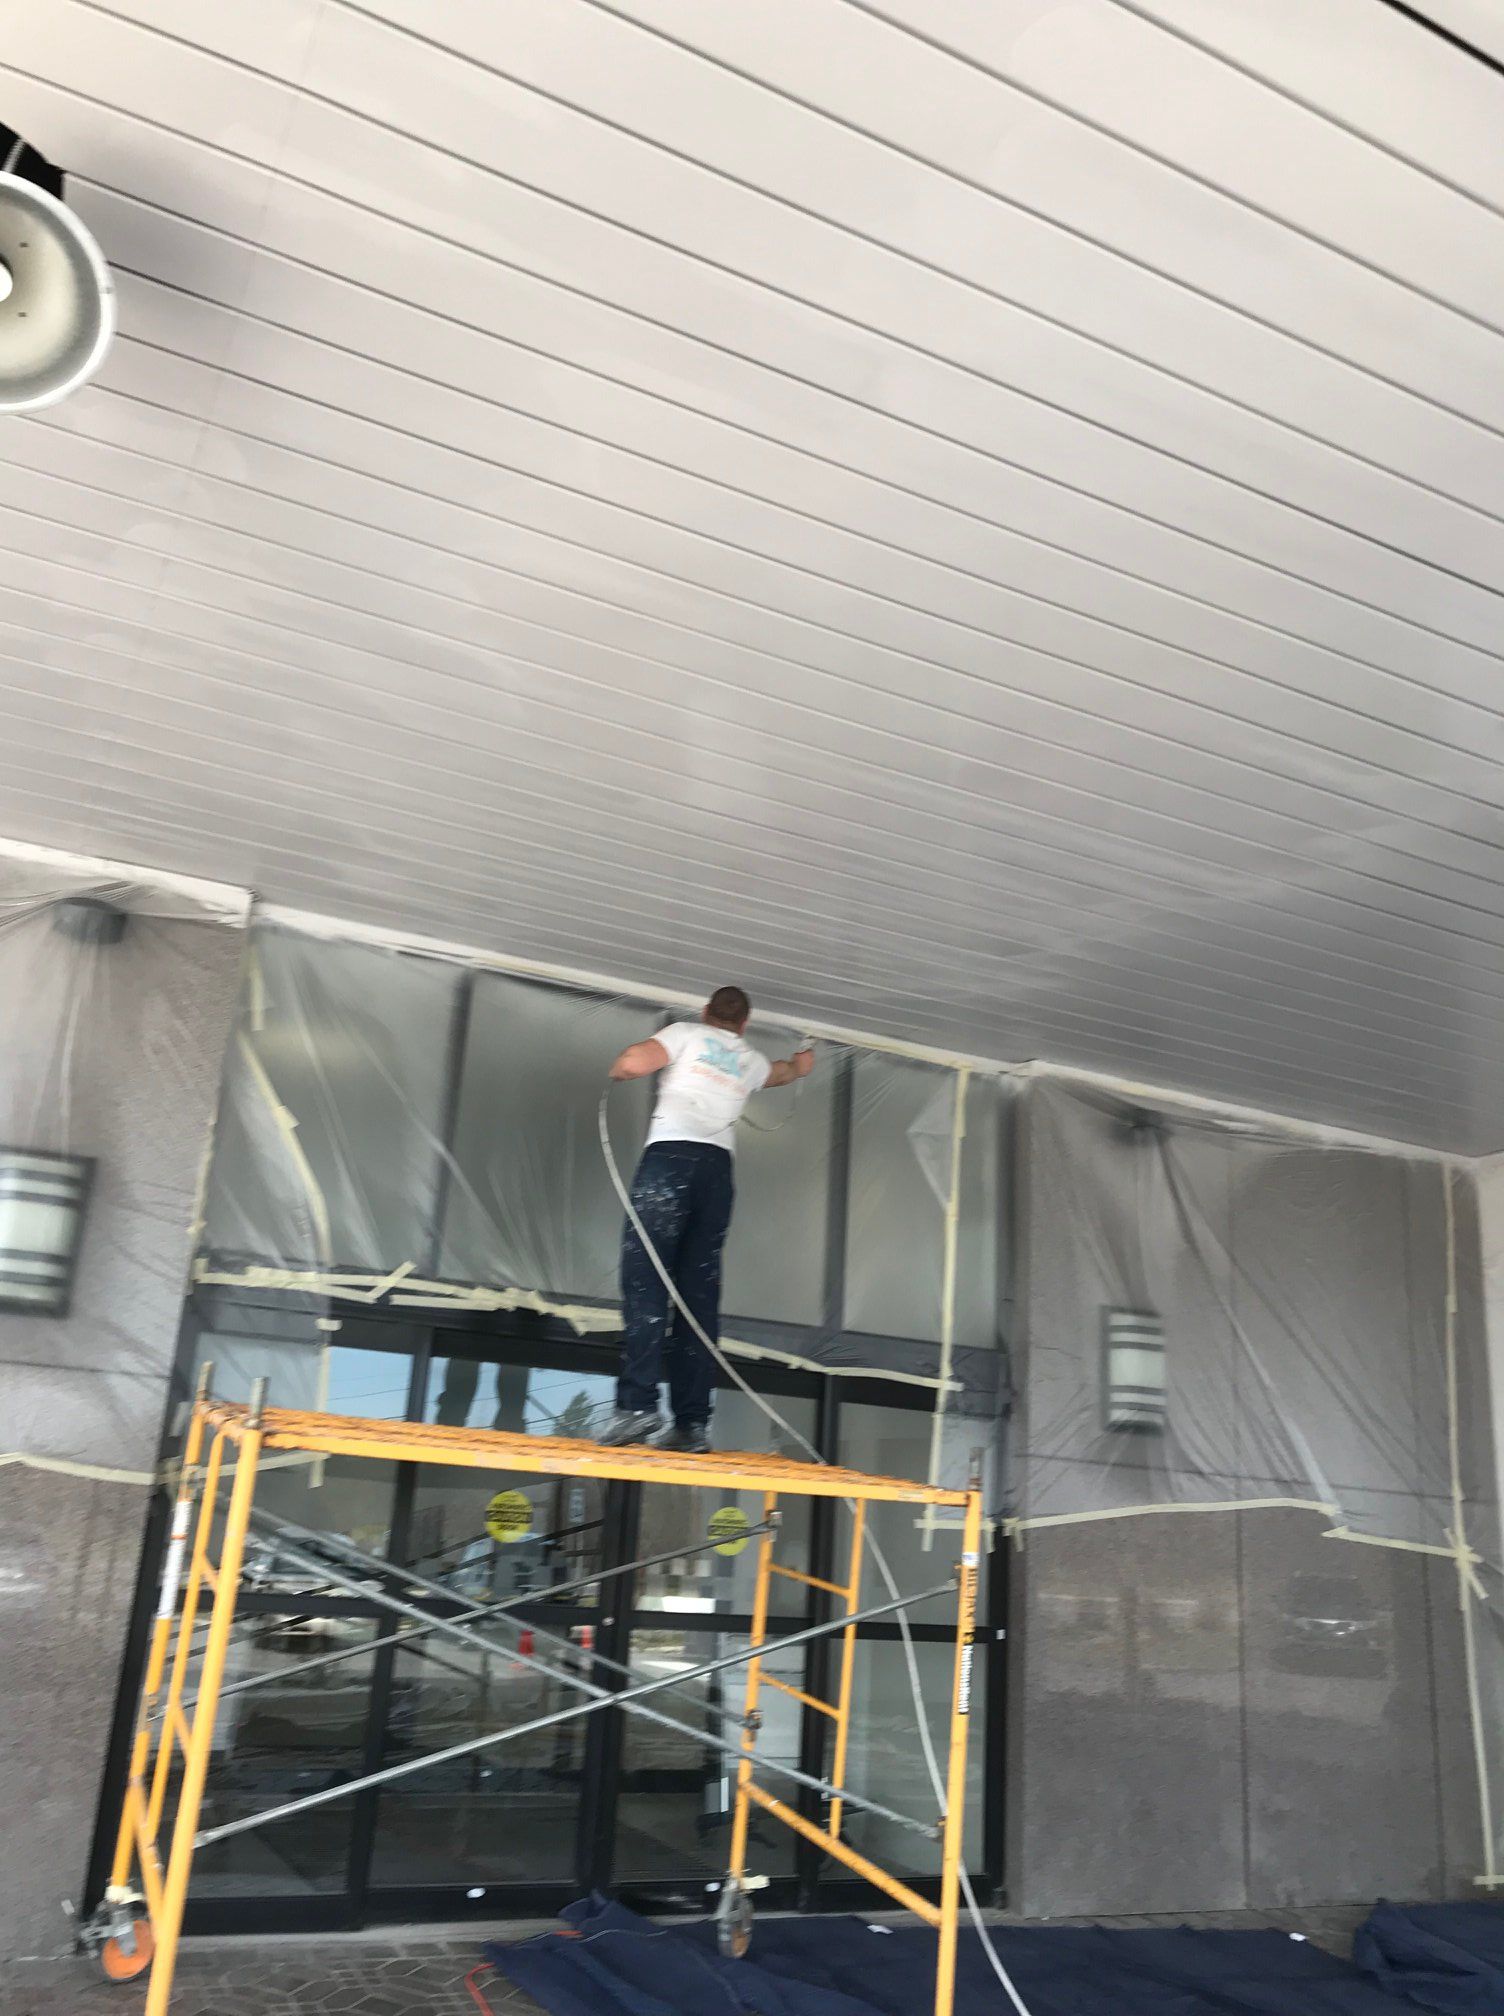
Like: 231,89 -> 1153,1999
202,927 -> 1004,1407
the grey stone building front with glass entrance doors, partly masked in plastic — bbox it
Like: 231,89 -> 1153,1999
0,887 -> 1496,1951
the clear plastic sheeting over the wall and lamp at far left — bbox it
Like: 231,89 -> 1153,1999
0,845 -> 250,1480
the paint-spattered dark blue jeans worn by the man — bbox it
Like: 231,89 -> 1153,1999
617,1141 -> 736,1427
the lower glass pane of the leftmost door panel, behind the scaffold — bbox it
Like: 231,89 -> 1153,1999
186,1617 -> 373,1897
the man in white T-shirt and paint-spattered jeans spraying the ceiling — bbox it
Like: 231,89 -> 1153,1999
599,988 -> 814,1452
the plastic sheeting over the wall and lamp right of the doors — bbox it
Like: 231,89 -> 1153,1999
1014,1083 -> 1494,1554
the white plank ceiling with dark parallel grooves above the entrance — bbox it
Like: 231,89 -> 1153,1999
0,0 -> 1504,1151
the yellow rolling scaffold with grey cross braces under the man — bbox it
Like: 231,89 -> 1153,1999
95,1367 -> 982,2016
